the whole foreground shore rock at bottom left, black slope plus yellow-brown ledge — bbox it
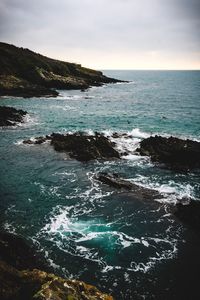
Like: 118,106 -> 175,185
0,232 -> 113,300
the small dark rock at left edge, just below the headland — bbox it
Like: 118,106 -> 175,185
0,106 -> 27,126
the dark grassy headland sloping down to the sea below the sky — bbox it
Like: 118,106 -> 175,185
0,43 -> 122,97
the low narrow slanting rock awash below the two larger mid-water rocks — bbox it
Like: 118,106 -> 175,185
96,173 -> 162,201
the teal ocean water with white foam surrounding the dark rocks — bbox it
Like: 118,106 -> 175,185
0,71 -> 200,300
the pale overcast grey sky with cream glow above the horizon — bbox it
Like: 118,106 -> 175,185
0,0 -> 200,70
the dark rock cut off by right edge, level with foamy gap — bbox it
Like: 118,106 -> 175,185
136,136 -> 200,171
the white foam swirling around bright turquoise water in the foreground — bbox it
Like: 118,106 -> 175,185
39,200 -> 177,273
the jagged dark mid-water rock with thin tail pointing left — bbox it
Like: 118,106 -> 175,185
24,132 -> 120,162
